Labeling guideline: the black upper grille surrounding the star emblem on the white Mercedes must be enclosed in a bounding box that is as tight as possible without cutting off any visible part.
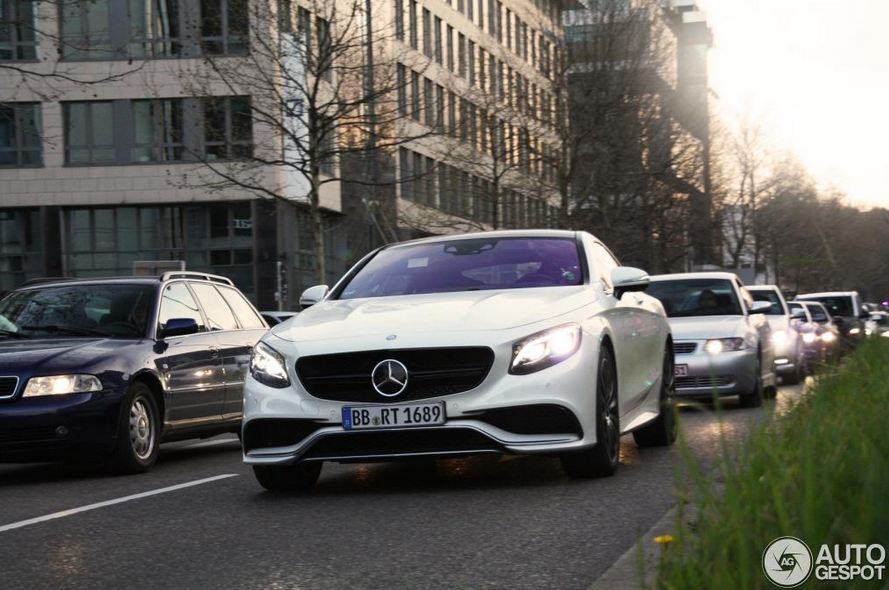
[296,346,494,403]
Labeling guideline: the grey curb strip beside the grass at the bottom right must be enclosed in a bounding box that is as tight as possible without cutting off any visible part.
[589,505,678,590]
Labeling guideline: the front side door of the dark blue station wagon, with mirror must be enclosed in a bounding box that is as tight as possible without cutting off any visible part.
[156,281,225,429]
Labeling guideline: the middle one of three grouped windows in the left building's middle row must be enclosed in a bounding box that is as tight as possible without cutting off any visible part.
[130,98,185,162]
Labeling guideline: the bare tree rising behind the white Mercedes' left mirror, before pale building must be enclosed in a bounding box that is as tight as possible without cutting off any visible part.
[183,0,430,282]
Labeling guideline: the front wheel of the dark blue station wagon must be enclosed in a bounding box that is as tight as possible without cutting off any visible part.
[111,381,160,473]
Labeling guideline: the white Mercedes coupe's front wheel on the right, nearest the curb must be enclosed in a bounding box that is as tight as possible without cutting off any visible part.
[561,346,620,479]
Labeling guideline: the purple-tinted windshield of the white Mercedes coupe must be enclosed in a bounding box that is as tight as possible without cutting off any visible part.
[339,238,583,299]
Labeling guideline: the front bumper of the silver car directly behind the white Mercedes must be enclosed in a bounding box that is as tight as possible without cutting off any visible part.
[675,341,757,397]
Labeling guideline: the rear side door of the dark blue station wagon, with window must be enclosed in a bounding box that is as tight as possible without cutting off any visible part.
[192,282,267,420]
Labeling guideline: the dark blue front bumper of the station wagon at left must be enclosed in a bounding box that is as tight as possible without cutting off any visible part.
[0,391,123,463]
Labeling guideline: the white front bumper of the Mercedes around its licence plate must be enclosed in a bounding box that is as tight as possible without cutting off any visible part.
[242,334,599,465]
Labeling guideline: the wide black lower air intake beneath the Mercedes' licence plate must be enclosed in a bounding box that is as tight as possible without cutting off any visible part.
[303,428,503,460]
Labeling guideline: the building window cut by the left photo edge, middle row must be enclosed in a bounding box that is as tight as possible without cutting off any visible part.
[0,102,43,168]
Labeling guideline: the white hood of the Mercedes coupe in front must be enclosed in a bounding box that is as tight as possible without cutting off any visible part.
[272,286,594,342]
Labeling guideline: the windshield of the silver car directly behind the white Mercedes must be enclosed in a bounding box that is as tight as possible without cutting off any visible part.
[645,279,741,318]
